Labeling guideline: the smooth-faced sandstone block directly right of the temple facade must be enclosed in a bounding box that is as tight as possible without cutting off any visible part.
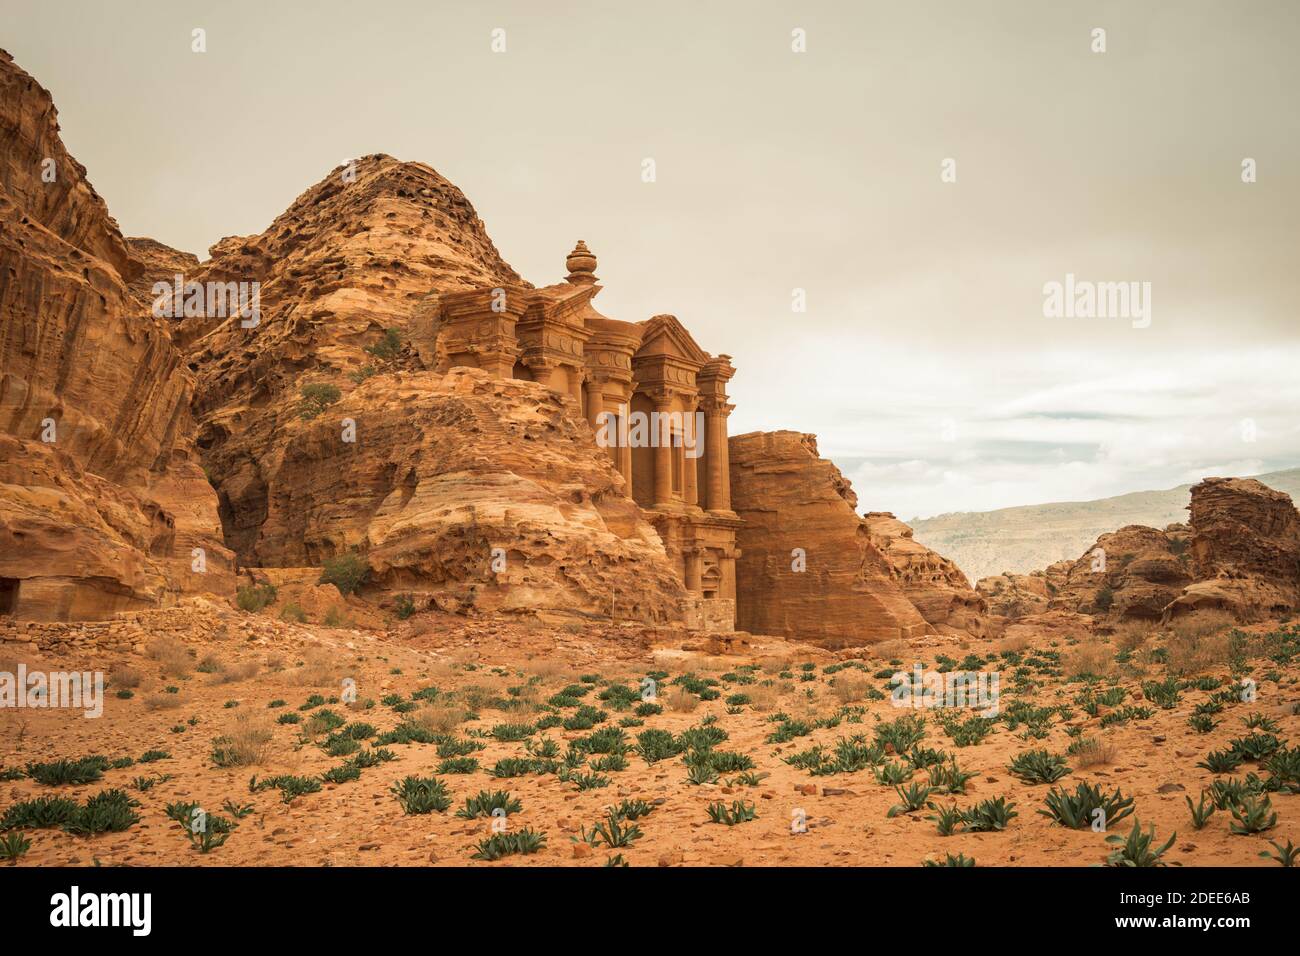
[729,432,978,648]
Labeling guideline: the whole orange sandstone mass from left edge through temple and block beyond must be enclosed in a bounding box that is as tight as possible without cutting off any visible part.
[0,48,984,646]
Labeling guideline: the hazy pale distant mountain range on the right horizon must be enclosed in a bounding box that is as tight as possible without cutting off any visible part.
[911,468,1300,584]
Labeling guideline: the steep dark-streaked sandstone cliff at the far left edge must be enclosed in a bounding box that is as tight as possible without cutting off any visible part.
[0,53,233,619]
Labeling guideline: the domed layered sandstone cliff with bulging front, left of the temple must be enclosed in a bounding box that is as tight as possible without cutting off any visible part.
[183,155,685,622]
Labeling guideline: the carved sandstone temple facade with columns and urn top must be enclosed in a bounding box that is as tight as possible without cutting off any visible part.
[434,241,741,631]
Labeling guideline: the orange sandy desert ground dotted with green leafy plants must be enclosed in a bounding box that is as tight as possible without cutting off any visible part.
[0,606,1300,866]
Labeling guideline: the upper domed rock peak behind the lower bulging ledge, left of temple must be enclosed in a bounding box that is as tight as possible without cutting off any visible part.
[182,156,521,564]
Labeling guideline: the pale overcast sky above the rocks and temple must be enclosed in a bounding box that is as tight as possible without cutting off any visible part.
[10,0,1300,519]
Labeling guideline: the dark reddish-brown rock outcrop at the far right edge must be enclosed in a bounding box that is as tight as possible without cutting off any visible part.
[1167,477,1300,620]
